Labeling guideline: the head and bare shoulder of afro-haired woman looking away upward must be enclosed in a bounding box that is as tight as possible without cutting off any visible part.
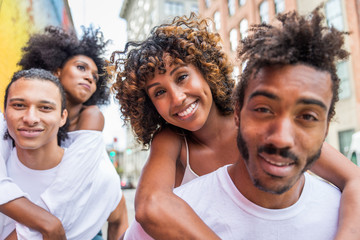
[18,26,109,131]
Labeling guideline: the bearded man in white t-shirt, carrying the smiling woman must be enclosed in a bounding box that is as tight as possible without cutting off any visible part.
[125,6,348,240]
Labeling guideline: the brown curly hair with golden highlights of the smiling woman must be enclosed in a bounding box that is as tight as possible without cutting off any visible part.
[111,13,234,146]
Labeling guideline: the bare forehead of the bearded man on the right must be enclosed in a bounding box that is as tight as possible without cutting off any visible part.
[245,64,333,105]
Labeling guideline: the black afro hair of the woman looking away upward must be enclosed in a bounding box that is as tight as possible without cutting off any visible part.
[18,26,110,105]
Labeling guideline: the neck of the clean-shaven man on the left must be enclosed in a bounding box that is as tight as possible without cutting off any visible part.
[16,144,64,170]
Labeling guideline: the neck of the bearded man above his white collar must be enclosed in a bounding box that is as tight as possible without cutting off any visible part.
[228,159,305,209]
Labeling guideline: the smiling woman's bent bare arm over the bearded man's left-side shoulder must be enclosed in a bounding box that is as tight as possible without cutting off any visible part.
[135,129,219,240]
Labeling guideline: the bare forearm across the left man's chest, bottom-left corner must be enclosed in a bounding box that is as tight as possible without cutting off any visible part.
[0,197,66,239]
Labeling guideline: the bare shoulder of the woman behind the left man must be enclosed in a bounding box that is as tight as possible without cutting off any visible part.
[77,105,105,131]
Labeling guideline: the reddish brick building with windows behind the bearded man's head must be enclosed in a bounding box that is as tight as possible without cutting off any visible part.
[199,0,360,161]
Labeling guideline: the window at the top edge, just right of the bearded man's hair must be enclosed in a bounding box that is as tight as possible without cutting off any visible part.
[325,0,344,31]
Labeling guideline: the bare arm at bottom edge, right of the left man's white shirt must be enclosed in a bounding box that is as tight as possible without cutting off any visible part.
[108,195,129,240]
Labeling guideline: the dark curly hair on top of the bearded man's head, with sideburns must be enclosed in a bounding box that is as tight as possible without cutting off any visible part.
[233,4,349,121]
